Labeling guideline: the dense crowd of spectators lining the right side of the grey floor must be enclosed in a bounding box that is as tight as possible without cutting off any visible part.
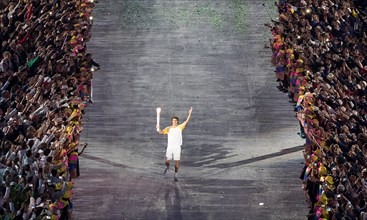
[269,0,367,220]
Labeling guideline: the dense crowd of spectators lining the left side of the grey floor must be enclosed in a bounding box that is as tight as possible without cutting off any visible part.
[0,0,98,220]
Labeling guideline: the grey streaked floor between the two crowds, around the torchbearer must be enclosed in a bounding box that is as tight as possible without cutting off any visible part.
[73,0,307,220]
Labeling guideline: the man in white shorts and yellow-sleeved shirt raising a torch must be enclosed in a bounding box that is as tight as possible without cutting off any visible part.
[157,107,192,181]
